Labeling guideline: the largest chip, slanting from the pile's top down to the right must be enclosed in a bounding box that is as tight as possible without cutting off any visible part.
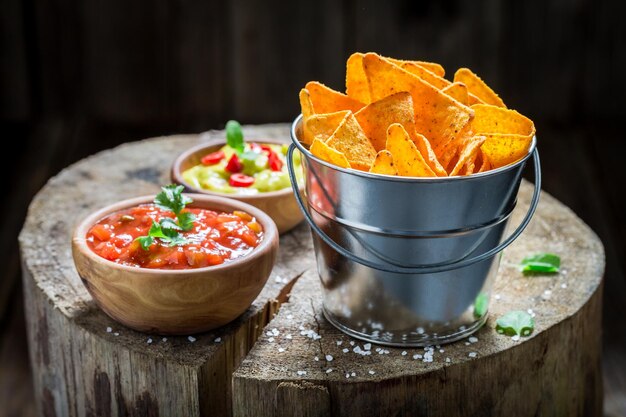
[363,54,473,154]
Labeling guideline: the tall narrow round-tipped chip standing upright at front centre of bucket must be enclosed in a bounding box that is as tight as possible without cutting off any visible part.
[387,123,436,177]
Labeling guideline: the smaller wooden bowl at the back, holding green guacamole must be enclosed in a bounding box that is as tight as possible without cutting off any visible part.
[171,139,304,234]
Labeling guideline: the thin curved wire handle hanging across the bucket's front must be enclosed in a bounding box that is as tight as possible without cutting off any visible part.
[287,143,541,274]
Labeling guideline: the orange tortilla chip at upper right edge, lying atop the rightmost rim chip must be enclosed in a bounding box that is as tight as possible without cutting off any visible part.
[472,104,535,136]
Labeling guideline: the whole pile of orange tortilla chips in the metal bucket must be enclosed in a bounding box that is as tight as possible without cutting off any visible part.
[300,53,535,177]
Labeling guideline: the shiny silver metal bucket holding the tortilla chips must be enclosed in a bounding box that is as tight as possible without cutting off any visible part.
[287,116,541,346]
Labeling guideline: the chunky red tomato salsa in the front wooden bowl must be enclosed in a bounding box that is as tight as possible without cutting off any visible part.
[87,204,263,269]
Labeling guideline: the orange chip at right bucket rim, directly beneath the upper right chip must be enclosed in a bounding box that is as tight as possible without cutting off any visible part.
[481,133,532,169]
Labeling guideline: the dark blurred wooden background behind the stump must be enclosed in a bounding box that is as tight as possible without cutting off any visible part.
[0,0,626,416]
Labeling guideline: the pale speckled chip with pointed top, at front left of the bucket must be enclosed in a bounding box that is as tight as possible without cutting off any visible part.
[326,112,376,171]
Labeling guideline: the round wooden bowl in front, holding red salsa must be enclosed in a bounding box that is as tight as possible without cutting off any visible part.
[72,194,278,334]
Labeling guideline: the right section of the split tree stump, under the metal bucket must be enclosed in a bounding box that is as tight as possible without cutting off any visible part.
[233,183,604,417]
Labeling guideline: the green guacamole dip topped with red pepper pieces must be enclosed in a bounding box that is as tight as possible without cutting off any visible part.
[183,143,303,195]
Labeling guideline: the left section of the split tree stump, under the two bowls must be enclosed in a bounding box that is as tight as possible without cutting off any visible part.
[20,125,313,417]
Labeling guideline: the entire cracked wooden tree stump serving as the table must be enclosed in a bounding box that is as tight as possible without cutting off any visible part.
[20,125,604,417]
